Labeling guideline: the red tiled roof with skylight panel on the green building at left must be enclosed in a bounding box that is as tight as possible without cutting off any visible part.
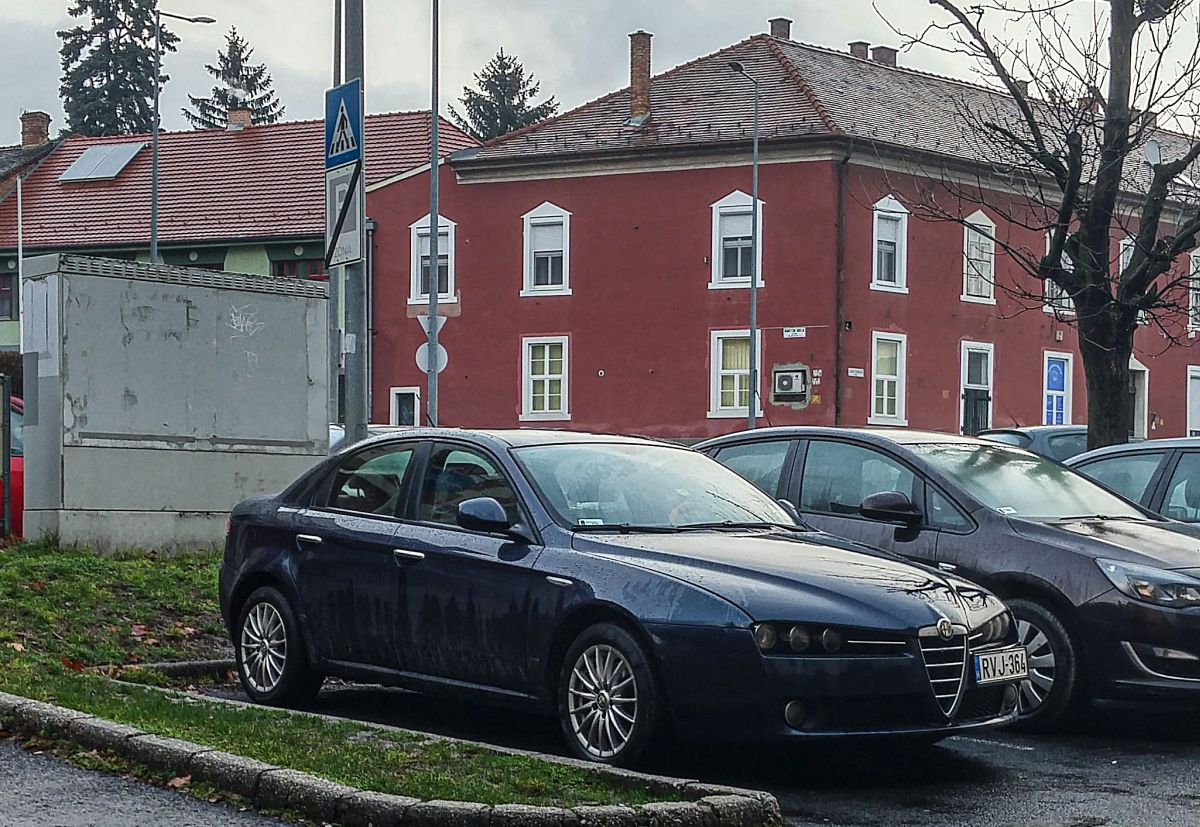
[0,112,476,250]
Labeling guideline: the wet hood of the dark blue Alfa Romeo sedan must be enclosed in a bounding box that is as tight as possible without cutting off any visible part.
[575,531,1001,631]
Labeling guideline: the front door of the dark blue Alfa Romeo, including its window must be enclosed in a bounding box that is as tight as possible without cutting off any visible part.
[396,442,560,694]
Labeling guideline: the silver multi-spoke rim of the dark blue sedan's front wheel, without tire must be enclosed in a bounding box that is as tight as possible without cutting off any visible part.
[568,643,637,759]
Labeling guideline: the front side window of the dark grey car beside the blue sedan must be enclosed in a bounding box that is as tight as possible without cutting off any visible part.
[800,441,916,515]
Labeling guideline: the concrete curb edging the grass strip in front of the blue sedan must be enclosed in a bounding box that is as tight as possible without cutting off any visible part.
[0,688,782,827]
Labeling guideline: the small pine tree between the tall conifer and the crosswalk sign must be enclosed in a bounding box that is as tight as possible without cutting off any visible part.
[184,28,283,130]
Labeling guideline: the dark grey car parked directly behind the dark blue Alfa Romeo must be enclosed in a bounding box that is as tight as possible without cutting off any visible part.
[697,427,1200,729]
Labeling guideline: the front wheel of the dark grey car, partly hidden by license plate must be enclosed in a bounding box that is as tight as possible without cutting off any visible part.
[1006,598,1084,732]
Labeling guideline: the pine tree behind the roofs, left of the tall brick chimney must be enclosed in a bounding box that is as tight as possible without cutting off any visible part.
[450,47,558,140]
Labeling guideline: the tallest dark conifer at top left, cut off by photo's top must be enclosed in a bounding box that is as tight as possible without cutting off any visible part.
[58,0,179,136]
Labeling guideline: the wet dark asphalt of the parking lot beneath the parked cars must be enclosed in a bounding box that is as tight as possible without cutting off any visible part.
[211,685,1200,827]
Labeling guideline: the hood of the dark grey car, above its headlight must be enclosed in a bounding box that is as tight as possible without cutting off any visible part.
[1009,519,1200,569]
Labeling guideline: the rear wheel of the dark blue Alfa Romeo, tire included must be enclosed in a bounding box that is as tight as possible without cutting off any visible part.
[234,586,324,706]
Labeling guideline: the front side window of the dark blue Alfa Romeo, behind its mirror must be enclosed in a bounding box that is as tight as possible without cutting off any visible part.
[416,445,521,526]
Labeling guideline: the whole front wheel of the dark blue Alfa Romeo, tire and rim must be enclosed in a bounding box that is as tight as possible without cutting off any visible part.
[558,623,662,767]
